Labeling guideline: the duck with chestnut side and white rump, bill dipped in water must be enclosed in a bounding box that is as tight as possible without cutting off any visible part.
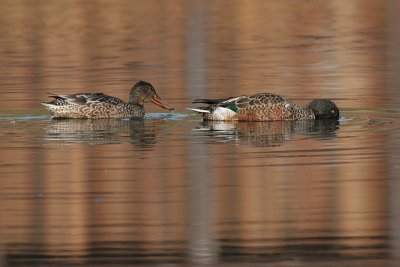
[189,93,339,121]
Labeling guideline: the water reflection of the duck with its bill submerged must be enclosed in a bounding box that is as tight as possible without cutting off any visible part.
[198,119,339,146]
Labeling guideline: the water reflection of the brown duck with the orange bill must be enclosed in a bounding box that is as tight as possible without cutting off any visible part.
[46,119,162,147]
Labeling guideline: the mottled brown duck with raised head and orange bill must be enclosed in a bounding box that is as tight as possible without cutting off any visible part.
[41,81,174,119]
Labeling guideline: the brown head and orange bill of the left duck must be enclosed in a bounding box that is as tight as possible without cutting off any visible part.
[128,81,174,110]
